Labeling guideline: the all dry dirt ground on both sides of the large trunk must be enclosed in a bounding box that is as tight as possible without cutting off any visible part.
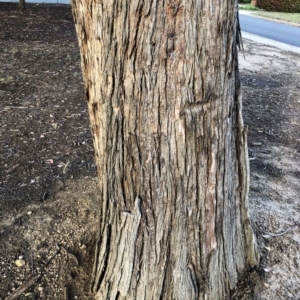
[0,3,300,300]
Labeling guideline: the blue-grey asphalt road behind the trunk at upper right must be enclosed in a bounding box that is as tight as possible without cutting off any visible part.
[239,14,300,47]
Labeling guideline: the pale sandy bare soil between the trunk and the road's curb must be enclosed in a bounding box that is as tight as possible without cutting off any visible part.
[240,41,300,300]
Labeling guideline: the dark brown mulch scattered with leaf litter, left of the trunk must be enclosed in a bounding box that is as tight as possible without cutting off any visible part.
[0,3,96,218]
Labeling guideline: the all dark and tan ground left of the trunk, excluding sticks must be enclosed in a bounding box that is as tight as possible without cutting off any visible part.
[0,3,97,300]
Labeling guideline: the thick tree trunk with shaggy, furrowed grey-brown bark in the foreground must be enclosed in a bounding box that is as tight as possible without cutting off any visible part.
[72,0,258,300]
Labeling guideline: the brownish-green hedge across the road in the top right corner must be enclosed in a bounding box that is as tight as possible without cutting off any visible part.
[256,0,300,13]
